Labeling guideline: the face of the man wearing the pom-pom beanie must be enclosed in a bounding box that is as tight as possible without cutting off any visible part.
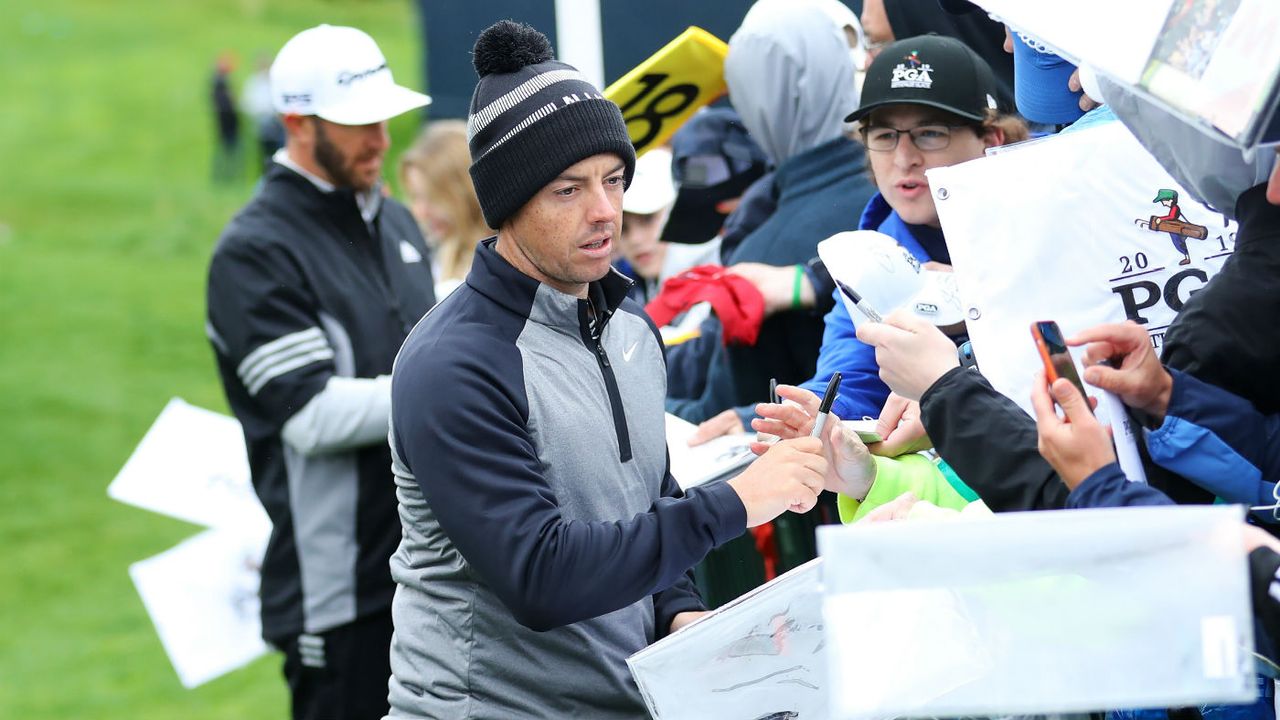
[498,152,626,297]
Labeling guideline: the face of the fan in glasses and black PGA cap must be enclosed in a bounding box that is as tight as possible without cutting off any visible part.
[867,105,996,227]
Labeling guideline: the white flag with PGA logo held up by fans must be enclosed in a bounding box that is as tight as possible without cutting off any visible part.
[927,122,1235,448]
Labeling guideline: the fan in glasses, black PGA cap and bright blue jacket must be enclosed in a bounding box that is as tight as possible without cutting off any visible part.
[768,35,1027,455]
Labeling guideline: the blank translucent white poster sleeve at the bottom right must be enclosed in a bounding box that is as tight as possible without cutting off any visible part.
[819,505,1256,720]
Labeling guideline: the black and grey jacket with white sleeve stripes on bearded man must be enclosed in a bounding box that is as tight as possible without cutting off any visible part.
[206,164,435,641]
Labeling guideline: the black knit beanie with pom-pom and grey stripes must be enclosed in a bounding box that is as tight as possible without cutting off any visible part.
[467,20,636,228]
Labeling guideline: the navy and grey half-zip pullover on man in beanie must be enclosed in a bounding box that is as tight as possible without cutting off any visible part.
[390,240,746,719]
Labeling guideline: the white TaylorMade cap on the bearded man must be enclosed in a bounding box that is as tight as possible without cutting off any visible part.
[270,24,431,126]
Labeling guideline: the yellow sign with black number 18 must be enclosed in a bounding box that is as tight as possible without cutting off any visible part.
[604,27,728,155]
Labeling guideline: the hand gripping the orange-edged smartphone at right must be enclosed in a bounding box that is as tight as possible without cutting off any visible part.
[1032,372,1116,489]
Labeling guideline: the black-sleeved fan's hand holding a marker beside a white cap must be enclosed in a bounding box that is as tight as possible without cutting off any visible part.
[858,310,960,401]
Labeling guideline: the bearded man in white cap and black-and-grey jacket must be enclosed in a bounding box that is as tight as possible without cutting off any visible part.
[205,26,435,719]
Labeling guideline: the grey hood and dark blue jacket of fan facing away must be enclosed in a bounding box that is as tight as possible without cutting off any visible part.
[724,0,874,405]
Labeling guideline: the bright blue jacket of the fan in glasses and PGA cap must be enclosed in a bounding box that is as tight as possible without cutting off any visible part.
[801,193,932,419]
